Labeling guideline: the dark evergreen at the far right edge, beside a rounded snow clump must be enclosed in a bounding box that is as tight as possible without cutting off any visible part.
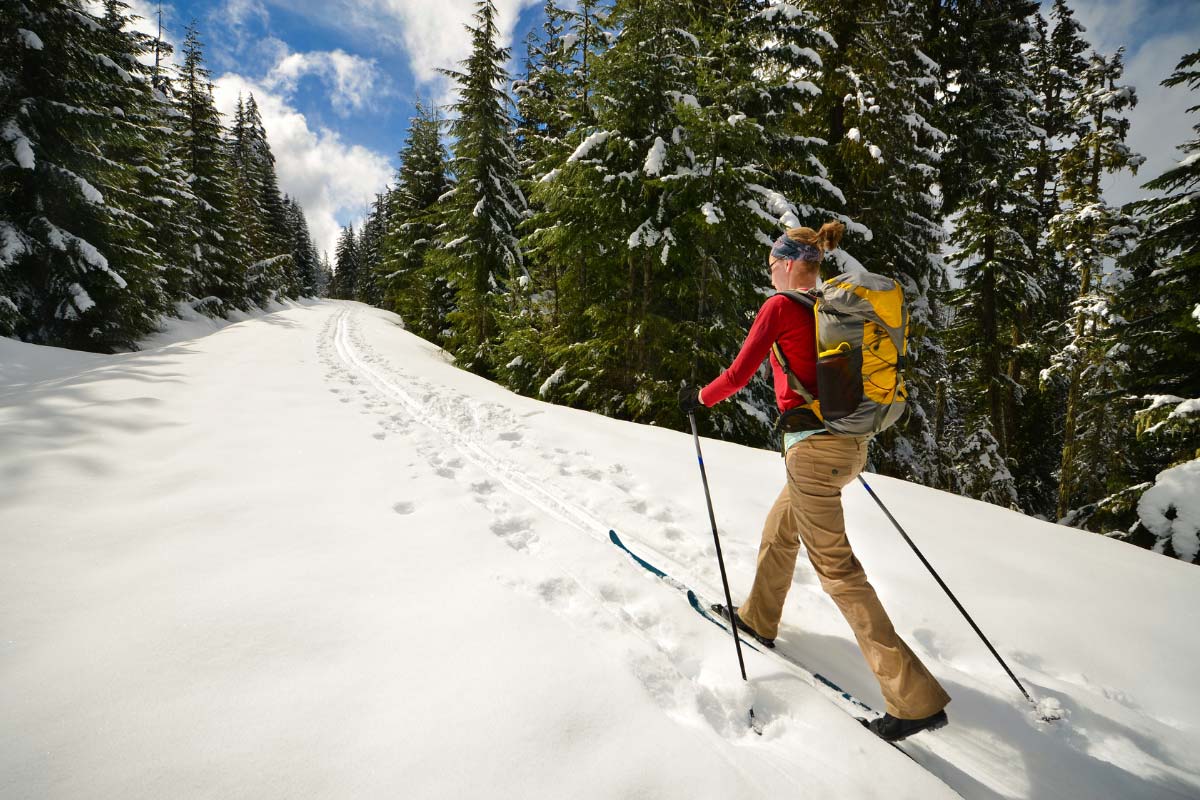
[1076,50,1200,561]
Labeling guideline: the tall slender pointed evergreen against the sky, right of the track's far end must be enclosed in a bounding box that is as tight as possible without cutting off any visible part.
[437,0,526,374]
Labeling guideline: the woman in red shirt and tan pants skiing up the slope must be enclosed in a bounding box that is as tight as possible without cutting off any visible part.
[679,222,950,741]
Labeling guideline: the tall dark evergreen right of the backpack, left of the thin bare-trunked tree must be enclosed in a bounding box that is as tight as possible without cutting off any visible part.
[935,0,1043,506]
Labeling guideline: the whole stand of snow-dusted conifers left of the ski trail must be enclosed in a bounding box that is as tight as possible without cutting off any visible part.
[0,0,325,353]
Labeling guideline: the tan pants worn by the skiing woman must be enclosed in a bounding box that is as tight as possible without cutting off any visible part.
[738,434,950,720]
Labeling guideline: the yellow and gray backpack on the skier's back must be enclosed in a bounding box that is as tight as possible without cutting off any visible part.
[773,272,908,437]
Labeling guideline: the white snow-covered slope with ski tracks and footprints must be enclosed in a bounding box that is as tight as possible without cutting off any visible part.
[0,302,1200,800]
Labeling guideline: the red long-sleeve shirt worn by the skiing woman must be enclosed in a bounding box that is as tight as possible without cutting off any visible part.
[701,294,817,411]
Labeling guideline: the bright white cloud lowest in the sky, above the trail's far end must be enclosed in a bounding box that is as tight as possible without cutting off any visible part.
[214,73,392,258]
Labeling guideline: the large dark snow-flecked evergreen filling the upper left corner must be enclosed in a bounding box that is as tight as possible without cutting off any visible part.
[0,0,167,351]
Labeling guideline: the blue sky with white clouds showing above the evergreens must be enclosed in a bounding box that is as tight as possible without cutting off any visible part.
[126,0,1200,260]
